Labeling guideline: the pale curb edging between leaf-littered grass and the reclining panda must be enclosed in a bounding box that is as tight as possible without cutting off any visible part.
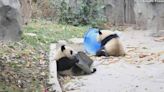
[49,44,62,92]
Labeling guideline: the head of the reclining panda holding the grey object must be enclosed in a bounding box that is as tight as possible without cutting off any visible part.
[55,45,76,60]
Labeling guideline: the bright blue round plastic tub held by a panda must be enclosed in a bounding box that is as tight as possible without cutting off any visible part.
[84,28,101,55]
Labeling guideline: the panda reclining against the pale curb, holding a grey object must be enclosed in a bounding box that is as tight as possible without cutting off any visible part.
[55,45,96,75]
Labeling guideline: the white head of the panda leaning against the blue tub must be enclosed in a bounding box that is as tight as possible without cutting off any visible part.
[97,30,113,42]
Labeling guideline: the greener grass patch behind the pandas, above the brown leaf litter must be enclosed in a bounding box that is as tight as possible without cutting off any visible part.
[22,20,89,49]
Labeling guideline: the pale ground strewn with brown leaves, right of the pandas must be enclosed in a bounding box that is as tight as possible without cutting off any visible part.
[56,31,164,92]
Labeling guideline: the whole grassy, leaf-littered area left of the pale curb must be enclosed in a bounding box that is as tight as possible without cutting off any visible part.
[0,20,88,92]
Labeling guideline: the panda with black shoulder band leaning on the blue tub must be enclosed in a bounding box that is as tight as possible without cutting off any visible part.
[96,30,125,56]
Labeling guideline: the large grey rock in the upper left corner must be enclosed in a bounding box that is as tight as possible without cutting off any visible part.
[0,0,22,41]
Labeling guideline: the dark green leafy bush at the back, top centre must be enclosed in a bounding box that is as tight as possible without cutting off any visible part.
[56,0,107,27]
